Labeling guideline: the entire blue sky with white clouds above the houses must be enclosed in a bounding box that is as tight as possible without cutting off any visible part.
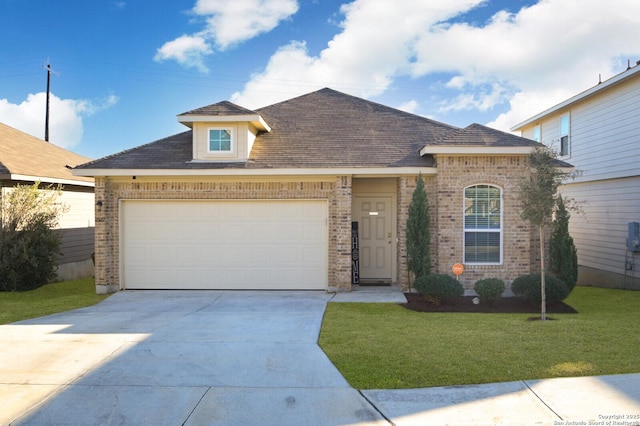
[0,0,640,158]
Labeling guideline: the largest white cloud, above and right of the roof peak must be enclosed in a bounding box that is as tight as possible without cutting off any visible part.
[232,0,640,130]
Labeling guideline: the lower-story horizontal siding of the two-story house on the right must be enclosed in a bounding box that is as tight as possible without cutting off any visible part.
[562,177,640,277]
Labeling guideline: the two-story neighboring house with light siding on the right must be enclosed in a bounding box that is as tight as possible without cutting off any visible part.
[513,65,640,289]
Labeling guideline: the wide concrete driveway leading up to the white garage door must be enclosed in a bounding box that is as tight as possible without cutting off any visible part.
[0,291,388,426]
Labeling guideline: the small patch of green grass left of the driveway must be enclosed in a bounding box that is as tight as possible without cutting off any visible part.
[0,278,108,324]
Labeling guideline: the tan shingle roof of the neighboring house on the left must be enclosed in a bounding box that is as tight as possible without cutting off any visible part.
[0,123,93,182]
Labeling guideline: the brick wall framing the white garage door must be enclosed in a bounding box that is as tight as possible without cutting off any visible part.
[95,176,351,293]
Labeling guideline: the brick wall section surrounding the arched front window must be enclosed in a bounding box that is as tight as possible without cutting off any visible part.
[436,155,531,289]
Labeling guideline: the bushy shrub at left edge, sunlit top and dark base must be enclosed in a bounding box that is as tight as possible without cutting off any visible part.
[0,182,65,291]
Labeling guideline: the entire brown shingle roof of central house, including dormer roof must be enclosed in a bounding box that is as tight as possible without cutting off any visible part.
[78,88,535,169]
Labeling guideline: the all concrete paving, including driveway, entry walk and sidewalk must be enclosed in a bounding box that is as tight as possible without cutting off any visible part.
[0,287,640,425]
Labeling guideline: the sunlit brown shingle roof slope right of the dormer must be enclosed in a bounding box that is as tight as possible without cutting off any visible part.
[250,89,456,168]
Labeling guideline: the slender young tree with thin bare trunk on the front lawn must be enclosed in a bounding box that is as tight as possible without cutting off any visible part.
[519,145,566,321]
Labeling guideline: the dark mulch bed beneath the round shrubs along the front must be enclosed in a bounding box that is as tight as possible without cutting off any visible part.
[400,293,578,314]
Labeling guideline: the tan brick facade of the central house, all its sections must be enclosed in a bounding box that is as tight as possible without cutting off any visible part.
[95,155,539,293]
